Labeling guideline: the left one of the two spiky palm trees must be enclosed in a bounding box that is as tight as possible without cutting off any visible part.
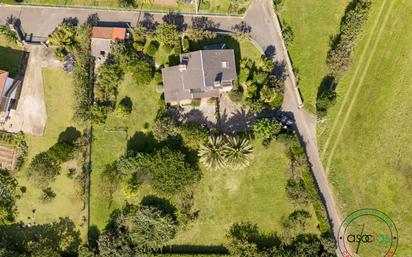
[199,136,226,170]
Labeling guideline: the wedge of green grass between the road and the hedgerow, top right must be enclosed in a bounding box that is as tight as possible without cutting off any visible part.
[280,0,349,113]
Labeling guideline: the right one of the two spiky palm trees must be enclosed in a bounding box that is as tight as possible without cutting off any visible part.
[224,136,253,169]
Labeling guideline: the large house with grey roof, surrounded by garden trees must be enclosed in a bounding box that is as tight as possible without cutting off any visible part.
[162,49,237,105]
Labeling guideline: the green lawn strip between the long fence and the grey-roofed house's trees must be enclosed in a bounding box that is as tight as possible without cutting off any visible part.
[90,76,160,229]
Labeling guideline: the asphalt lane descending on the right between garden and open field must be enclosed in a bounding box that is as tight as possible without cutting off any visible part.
[244,0,341,238]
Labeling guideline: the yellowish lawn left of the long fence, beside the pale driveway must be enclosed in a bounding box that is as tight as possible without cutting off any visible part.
[16,69,86,238]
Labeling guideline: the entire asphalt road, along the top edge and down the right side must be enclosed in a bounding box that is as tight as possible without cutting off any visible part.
[0,0,341,240]
